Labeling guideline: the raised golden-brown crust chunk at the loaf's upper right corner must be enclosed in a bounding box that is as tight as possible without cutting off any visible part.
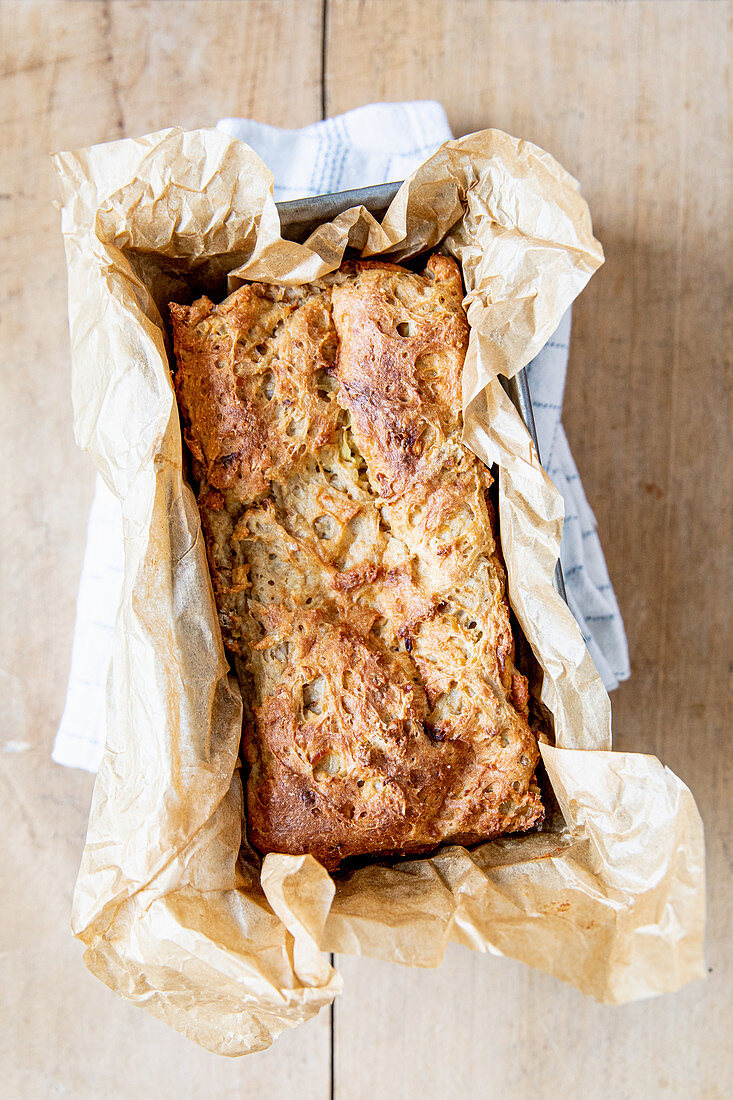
[333,255,468,497]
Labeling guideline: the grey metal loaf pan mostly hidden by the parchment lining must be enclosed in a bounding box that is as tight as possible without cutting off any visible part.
[277,182,567,602]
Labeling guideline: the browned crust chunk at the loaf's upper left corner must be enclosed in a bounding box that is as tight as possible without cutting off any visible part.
[171,283,336,501]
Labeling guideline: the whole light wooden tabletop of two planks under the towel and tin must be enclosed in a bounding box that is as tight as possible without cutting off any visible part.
[0,0,733,1100]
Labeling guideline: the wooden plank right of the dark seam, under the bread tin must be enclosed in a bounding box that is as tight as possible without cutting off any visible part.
[326,0,733,1100]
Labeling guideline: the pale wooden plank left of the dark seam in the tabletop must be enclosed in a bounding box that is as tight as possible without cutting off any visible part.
[0,0,330,1100]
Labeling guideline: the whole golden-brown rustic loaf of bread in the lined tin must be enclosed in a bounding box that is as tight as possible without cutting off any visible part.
[171,254,543,869]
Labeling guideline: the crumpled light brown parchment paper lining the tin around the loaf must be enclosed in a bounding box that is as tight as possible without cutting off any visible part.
[55,130,703,1054]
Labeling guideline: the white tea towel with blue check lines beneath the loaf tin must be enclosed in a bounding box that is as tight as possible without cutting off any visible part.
[53,101,628,771]
